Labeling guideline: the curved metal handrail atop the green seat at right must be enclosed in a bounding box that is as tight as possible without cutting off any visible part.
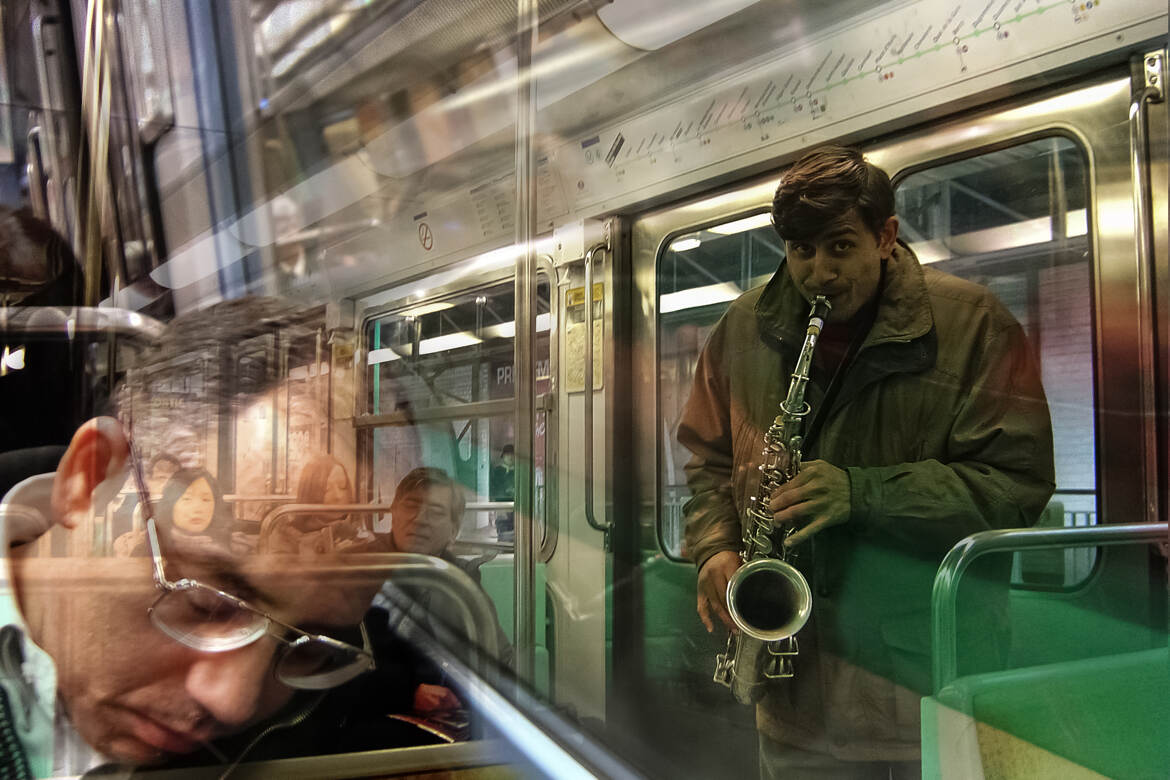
[930,523,1166,693]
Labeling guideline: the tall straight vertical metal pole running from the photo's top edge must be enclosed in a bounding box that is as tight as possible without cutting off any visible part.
[512,0,539,682]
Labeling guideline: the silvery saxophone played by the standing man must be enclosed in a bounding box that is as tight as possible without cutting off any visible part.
[714,295,832,704]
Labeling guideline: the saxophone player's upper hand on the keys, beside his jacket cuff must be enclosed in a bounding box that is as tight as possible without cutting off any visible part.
[768,461,852,547]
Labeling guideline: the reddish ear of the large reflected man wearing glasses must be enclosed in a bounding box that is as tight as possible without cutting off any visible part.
[53,417,130,529]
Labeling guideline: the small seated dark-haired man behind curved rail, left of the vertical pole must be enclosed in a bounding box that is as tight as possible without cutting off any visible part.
[374,467,511,716]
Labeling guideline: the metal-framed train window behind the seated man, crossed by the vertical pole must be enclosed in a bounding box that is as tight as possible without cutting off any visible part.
[355,263,564,692]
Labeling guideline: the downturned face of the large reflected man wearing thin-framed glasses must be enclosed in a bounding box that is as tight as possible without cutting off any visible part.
[17,411,374,764]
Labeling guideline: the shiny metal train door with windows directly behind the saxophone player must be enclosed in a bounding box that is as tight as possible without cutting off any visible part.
[615,62,1165,774]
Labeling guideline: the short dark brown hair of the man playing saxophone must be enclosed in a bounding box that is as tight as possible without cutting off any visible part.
[772,146,894,241]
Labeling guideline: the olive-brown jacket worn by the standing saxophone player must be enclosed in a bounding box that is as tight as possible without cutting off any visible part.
[679,243,1054,760]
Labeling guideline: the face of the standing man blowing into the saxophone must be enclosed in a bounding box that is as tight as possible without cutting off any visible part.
[784,210,897,323]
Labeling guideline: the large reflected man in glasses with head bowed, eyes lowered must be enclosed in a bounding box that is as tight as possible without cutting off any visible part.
[0,301,413,776]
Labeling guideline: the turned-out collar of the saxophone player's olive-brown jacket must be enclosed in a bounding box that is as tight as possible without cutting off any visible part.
[756,240,935,348]
